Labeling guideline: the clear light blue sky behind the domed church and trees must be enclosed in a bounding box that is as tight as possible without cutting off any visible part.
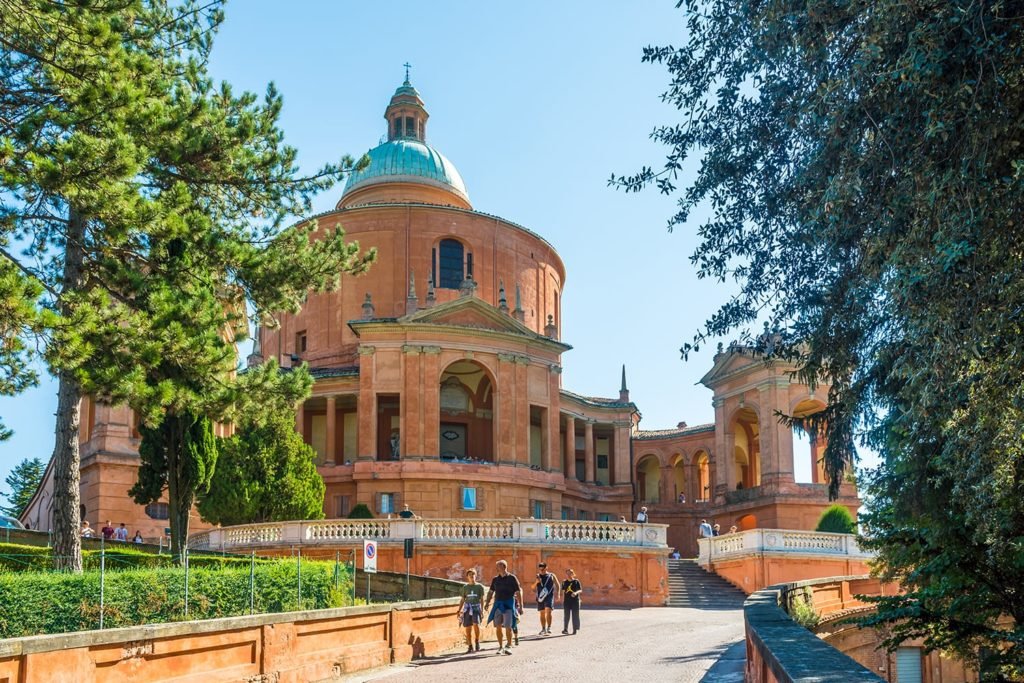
[0,0,835,490]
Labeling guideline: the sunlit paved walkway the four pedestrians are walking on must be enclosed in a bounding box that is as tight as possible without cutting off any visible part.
[344,605,743,683]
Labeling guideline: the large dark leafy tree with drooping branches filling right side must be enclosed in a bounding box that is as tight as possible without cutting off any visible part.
[611,0,1024,677]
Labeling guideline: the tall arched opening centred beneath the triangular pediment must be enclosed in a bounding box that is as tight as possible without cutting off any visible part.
[438,360,495,463]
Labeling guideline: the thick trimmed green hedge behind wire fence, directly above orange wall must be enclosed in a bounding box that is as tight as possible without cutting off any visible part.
[0,559,352,638]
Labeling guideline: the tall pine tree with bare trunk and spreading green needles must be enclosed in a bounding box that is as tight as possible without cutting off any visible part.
[0,0,373,570]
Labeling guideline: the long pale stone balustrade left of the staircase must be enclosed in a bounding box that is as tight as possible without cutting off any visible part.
[188,518,668,551]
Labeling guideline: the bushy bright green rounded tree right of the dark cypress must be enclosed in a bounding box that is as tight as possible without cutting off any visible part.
[199,410,325,526]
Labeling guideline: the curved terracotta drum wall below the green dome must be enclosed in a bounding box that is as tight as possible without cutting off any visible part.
[253,205,565,367]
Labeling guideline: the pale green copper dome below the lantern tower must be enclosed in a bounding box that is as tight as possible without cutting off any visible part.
[341,137,469,203]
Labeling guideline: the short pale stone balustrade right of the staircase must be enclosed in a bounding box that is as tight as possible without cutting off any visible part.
[697,528,874,566]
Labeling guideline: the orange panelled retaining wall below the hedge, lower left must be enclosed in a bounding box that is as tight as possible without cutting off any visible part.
[0,593,463,683]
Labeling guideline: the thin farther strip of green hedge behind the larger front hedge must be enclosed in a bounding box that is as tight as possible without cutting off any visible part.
[0,543,263,571]
